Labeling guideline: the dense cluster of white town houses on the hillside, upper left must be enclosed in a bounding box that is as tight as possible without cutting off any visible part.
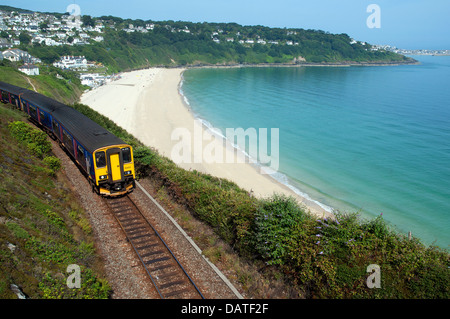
[0,11,112,87]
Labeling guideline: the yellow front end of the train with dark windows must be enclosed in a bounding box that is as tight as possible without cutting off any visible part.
[93,144,135,196]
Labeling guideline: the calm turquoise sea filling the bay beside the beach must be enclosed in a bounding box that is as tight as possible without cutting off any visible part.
[180,56,450,249]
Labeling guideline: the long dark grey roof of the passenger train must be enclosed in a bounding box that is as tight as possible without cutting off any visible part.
[0,81,125,153]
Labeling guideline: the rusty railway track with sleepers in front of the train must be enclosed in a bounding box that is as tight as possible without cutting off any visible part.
[104,196,204,299]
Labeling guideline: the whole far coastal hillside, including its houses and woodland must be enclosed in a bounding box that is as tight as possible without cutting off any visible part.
[0,7,414,73]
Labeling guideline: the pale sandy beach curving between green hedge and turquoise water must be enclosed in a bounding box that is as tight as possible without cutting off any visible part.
[80,68,332,217]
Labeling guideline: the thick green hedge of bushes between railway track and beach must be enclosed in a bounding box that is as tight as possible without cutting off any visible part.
[74,104,450,299]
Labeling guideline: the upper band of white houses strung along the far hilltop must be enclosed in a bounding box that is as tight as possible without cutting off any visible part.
[0,7,308,50]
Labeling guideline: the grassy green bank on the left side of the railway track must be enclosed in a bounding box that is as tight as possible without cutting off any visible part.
[0,106,111,299]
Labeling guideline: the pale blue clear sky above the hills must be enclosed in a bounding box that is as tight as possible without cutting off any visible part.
[0,0,450,49]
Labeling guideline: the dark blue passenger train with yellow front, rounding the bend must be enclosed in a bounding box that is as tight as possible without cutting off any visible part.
[0,81,136,197]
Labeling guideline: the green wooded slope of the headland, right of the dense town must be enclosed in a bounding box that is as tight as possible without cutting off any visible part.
[20,16,412,73]
